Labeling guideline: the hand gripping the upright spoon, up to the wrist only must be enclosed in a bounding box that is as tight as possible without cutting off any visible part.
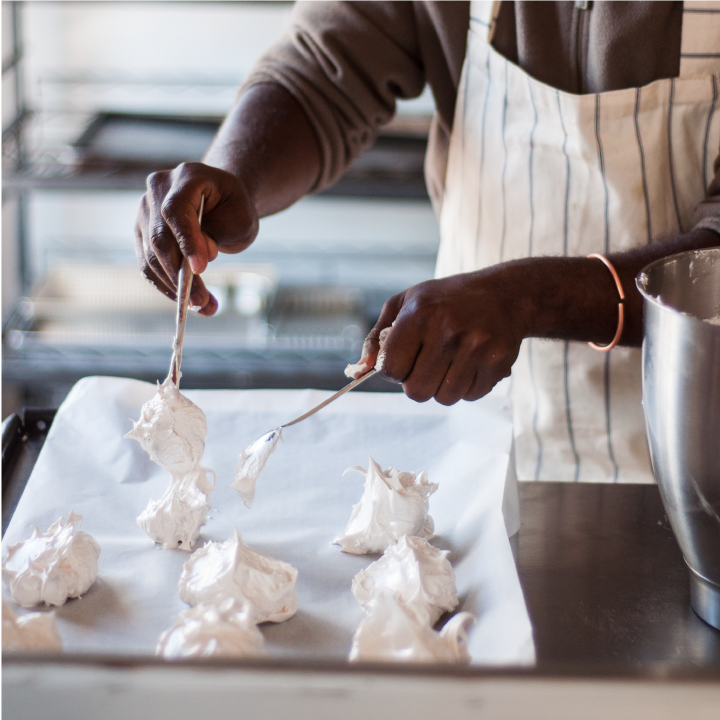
[135,163,258,315]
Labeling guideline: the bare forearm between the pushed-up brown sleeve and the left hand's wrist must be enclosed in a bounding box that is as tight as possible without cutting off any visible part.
[204,83,320,217]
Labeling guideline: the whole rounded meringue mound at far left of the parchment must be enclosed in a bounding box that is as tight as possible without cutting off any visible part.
[2,511,100,608]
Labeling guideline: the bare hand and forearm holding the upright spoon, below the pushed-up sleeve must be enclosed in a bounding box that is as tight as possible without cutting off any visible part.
[135,83,320,315]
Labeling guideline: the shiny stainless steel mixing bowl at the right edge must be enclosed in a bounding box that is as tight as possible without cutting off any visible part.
[636,248,720,629]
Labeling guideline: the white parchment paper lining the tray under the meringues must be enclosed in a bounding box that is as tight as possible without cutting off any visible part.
[2,377,534,664]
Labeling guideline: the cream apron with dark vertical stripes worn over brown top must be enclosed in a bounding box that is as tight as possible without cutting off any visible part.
[436,0,720,482]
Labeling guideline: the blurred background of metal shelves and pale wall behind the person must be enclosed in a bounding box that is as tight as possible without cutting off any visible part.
[2,0,439,418]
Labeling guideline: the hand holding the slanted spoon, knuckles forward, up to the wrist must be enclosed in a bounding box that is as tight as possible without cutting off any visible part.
[363,269,528,405]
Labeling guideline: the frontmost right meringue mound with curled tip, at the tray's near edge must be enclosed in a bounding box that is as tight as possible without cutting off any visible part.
[349,591,475,663]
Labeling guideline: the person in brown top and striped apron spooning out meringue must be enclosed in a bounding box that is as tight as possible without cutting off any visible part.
[136,0,720,482]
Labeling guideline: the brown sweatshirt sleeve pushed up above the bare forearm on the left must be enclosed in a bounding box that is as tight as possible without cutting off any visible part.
[240,0,425,190]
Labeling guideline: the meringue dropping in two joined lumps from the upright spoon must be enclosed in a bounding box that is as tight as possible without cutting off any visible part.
[125,378,215,552]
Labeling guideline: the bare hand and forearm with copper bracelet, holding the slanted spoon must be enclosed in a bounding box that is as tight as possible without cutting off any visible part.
[361,229,718,405]
